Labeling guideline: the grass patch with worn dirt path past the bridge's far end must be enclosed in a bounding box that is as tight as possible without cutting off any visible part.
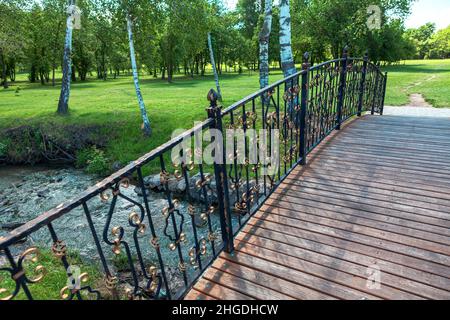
[383,59,450,107]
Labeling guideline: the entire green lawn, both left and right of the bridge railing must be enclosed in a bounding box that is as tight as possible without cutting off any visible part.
[0,60,450,171]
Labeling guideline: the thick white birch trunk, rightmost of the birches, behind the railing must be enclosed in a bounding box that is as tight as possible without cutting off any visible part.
[280,0,297,77]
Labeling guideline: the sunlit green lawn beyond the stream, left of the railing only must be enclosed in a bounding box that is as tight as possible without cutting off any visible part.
[0,71,282,171]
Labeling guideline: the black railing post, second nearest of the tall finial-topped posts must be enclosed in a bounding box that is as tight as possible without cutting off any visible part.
[297,52,310,165]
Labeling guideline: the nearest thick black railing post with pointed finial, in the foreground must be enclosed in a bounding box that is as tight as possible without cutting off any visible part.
[206,89,234,253]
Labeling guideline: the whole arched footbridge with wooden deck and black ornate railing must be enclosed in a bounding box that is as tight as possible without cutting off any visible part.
[0,52,450,300]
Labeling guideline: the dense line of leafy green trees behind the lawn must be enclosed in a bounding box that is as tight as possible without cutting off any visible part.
[0,0,450,87]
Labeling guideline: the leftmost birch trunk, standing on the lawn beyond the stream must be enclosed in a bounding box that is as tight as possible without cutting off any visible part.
[58,0,75,114]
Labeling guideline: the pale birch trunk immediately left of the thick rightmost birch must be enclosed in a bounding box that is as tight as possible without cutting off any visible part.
[259,0,272,89]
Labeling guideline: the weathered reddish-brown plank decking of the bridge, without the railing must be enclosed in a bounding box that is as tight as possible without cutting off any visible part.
[186,116,450,299]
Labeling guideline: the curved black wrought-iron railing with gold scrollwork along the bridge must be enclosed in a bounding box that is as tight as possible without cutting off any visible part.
[0,47,387,300]
